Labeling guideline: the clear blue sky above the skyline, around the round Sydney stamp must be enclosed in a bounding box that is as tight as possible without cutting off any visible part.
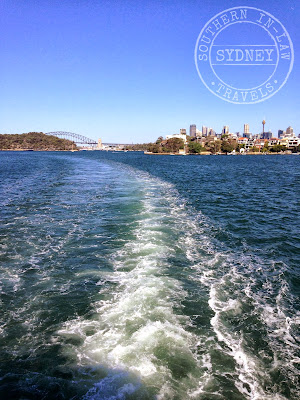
[0,0,300,143]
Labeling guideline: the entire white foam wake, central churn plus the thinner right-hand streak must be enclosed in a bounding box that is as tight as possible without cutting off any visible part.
[55,161,296,400]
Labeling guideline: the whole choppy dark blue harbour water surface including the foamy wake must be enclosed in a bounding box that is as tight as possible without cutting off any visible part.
[0,152,300,400]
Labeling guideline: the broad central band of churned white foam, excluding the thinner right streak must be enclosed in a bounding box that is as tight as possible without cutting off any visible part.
[59,176,203,399]
